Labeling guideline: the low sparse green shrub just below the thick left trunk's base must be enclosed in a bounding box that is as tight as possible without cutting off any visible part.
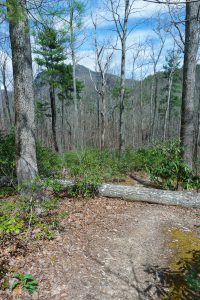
[0,192,68,243]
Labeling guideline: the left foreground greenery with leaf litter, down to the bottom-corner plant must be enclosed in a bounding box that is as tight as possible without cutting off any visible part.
[0,193,68,294]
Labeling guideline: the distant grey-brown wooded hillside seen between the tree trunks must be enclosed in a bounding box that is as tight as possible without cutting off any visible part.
[0,65,200,150]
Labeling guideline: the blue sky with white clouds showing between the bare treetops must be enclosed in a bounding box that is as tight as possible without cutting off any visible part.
[1,0,183,82]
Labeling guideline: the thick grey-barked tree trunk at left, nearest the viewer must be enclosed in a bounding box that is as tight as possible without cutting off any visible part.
[7,0,38,183]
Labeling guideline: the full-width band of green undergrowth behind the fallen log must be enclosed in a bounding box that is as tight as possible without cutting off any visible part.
[0,132,200,196]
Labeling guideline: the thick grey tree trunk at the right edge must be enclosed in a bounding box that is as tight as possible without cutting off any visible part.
[180,1,199,168]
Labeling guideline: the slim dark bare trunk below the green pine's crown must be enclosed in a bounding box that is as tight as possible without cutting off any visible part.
[49,86,59,152]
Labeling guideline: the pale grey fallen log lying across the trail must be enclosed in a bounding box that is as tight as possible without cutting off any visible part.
[59,180,200,208]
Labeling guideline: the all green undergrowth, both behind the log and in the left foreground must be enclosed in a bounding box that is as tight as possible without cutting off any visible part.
[0,132,200,293]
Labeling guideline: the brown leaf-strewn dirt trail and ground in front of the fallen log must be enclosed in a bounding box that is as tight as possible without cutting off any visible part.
[0,198,200,300]
